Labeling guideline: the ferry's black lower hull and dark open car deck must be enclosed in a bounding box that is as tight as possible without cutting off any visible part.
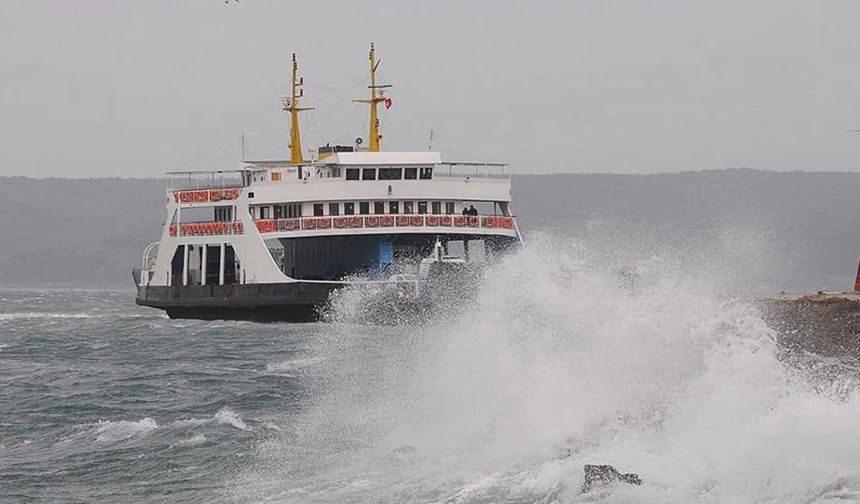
[136,234,519,321]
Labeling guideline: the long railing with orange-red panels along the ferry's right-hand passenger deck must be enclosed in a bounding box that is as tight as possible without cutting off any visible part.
[254,214,516,233]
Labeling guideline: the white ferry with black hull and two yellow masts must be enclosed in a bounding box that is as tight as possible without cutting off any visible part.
[135,45,522,321]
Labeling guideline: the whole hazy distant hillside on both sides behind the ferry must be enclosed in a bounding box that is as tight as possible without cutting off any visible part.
[0,170,860,290]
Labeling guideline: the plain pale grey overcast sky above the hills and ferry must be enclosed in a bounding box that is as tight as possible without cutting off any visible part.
[0,0,860,177]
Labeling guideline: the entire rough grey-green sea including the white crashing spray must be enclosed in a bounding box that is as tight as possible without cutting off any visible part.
[0,242,860,504]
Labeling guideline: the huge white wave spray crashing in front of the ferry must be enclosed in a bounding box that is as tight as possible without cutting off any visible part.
[232,237,860,503]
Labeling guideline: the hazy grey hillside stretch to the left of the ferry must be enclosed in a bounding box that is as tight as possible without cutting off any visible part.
[0,177,166,287]
